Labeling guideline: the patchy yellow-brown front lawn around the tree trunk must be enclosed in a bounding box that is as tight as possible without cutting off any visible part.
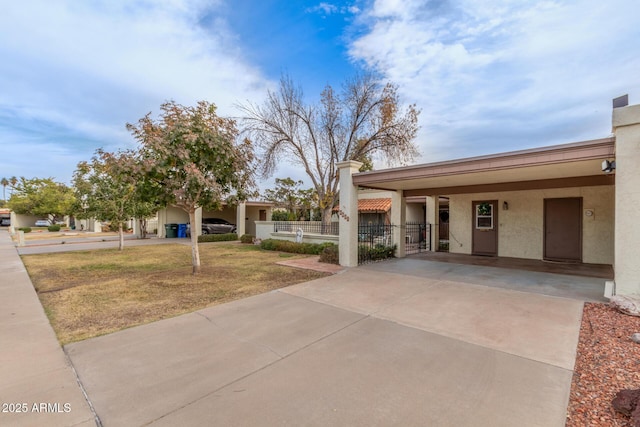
[22,243,326,345]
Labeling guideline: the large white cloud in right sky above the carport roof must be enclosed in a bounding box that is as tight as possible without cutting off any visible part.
[350,0,640,161]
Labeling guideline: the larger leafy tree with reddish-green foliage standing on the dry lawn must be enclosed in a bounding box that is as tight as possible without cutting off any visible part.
[127,101,253,274]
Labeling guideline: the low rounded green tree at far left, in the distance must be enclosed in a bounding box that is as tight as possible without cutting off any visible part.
[8,177,75,223]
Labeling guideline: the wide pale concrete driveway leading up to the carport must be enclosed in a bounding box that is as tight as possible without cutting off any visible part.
[66,263,583,427]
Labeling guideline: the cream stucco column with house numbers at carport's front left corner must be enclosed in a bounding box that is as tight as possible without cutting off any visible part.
[337,160,362,267]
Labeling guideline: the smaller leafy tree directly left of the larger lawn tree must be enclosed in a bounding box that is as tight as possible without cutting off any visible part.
[73,150,158,250]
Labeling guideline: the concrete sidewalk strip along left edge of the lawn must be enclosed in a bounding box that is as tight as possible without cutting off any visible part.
[0,230,96,426]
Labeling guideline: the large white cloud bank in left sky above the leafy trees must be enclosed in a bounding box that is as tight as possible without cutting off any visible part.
[0,0,269,162]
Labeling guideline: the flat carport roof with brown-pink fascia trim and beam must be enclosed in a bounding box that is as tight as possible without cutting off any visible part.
[353,137,615,197]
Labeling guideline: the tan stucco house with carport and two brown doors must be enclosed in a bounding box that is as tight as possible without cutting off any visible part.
[340,97,640,293]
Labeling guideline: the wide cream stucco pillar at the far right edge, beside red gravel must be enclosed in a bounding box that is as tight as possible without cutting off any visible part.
[603,105,640,295]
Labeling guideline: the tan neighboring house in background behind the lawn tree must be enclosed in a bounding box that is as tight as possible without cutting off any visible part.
[157,201,273,238]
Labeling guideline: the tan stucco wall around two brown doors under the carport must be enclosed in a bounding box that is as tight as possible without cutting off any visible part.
[449,186,614,264]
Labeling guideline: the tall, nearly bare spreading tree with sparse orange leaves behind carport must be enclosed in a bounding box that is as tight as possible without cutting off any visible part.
[240,74,419,231]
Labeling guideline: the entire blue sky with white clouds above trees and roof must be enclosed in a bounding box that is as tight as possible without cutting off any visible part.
[0,0,640,194]
